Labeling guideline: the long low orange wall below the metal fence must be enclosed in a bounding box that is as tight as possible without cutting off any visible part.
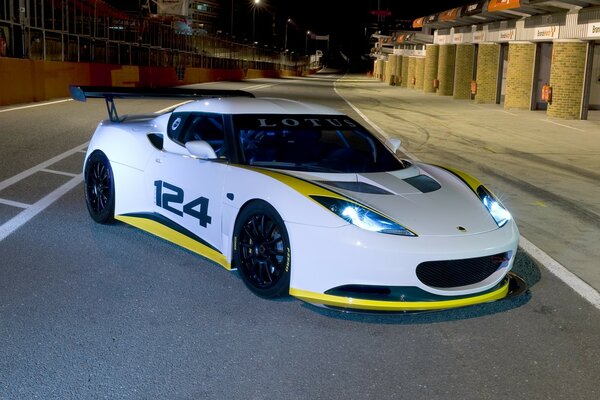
[0,58,300,106]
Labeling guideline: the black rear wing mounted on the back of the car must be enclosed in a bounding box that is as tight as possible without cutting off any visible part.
[69,85,254,122]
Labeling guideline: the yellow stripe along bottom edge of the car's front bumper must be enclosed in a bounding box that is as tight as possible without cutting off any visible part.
[290,279,509,311]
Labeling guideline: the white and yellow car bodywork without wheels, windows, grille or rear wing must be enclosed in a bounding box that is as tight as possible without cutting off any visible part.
[76,88,519,311]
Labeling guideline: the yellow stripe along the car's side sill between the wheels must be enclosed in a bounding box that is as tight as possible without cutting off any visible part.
[115,215,231,270]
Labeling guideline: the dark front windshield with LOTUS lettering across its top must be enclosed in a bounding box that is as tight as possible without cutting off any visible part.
[233,114,404,173]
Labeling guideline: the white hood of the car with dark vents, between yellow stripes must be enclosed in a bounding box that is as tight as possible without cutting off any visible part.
[286,165,498,236]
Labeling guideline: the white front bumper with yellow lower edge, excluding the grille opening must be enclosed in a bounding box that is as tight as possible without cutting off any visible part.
[287,222,519,311]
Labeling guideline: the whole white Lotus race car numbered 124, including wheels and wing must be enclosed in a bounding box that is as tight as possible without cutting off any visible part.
[71,87,519,311]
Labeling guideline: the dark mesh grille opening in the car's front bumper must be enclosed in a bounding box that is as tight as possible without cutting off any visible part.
[417,252,510,288]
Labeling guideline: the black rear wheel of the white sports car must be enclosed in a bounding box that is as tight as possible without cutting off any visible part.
[84,151,115,224]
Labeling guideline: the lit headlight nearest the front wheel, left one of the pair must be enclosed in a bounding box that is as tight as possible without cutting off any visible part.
[311,196,417,236]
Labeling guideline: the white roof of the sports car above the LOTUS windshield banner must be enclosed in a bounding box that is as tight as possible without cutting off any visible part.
[174,97,344,115]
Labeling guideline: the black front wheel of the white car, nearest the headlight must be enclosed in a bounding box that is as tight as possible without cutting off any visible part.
[233,201,291,298]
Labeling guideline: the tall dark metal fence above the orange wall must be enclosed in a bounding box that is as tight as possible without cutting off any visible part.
[0,0,308,73]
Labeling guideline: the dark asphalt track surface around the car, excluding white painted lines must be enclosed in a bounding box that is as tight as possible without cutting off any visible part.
[0,74,600,400]
